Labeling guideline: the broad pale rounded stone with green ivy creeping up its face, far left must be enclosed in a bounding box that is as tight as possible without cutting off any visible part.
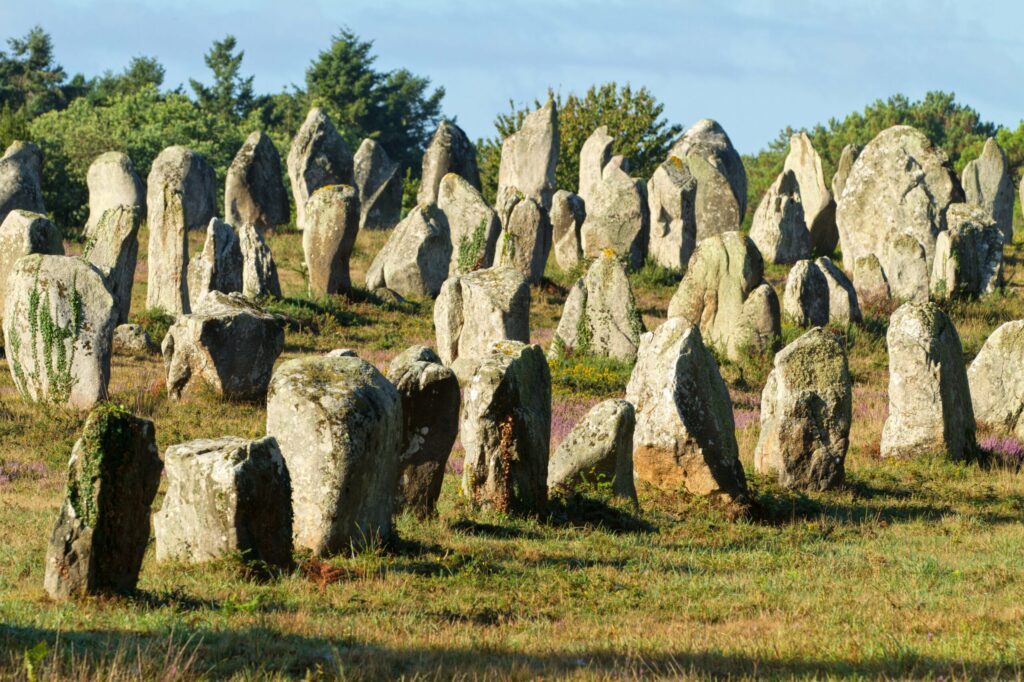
[3,254,117,410]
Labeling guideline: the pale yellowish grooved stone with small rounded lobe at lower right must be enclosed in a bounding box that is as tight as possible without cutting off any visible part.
[667,232,780,360]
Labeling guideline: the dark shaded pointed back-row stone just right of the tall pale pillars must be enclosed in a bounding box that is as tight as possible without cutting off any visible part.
[224,130,291,233]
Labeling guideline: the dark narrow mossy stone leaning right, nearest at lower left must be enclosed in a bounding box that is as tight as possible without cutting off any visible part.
[43,404,163,599]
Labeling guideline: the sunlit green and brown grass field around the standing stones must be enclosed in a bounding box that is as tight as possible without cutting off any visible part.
[0,225,1024,680]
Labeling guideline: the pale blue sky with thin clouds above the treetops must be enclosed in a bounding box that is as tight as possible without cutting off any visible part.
[0,0,1024,153]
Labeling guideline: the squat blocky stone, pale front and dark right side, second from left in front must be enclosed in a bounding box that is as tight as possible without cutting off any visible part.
[153,436,292,568]
